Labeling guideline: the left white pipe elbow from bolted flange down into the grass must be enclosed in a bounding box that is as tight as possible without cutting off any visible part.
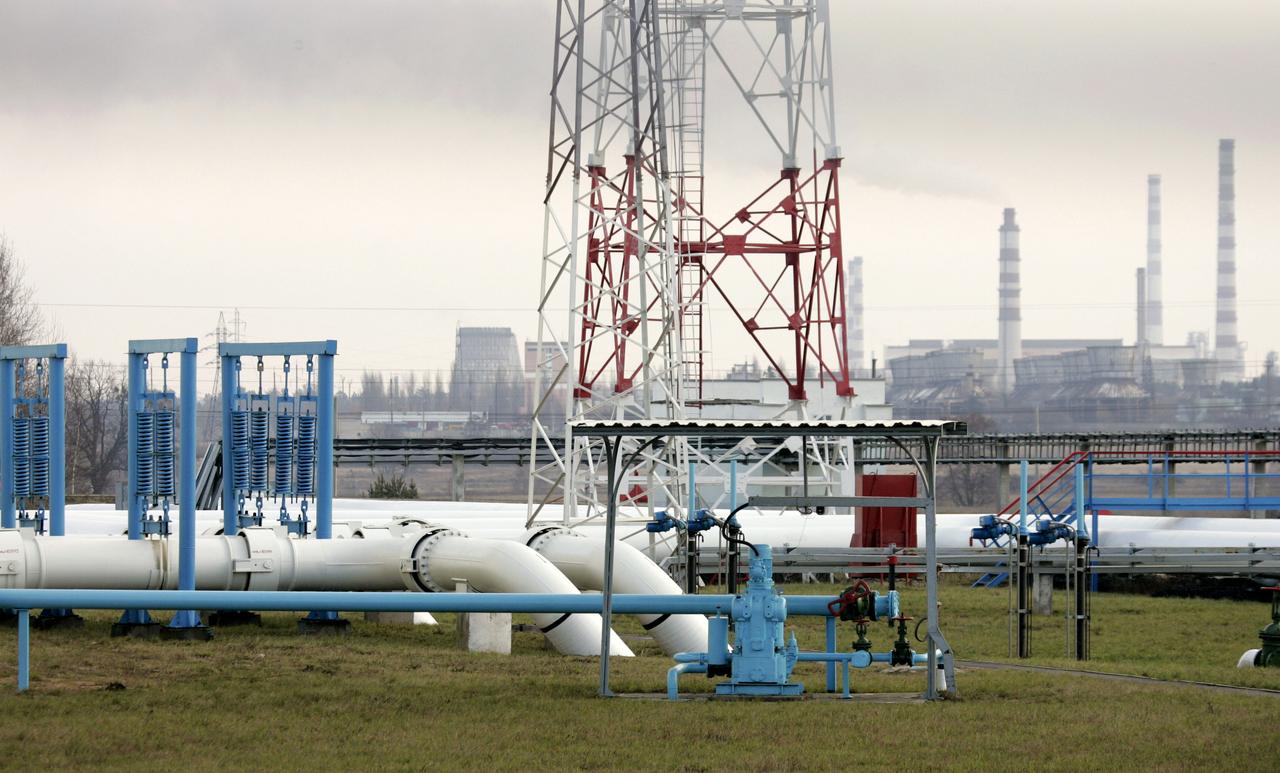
[413,529,634,658]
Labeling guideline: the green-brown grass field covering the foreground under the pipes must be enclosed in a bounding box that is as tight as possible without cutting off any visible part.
[0,582,1280,770]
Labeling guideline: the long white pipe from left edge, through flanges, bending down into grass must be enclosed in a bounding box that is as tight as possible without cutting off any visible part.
[0,523,634,657]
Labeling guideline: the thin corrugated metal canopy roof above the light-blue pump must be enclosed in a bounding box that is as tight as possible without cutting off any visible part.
[570,418,968,438]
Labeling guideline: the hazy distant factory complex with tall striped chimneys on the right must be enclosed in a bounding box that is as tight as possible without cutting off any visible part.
[880,139,1275,431]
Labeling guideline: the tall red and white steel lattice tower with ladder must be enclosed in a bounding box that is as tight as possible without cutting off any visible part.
[530,0,852,521]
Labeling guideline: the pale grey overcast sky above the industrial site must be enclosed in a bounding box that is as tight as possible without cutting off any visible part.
[0,0,1280,381]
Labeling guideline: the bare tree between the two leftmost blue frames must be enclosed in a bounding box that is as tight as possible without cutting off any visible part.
[67,361,129,494]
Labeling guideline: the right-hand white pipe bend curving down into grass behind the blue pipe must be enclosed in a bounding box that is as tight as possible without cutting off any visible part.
[525,526,707,655]
